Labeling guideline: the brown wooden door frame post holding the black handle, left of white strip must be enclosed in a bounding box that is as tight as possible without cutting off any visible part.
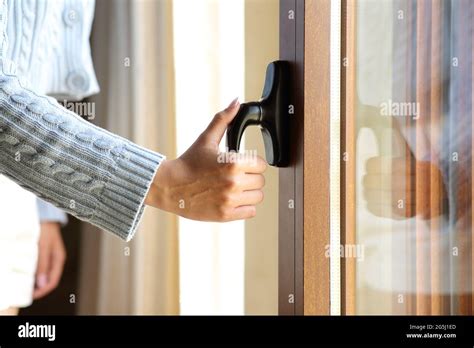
[278,0,331,315]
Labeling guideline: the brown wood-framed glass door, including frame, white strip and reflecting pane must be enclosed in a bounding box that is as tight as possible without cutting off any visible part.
[279,0,474,315]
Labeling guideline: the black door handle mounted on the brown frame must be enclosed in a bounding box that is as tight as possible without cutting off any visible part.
[226,61,290,167]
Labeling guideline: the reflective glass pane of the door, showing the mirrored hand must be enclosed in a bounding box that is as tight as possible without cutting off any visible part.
[343,0,474,315]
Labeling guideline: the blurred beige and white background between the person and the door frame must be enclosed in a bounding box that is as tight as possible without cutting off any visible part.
[21,0,279,315]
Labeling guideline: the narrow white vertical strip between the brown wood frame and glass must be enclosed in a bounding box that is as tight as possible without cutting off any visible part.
[329,0,342,315]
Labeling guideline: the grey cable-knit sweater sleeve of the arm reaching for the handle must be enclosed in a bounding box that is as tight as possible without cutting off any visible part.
[0,65,164,241]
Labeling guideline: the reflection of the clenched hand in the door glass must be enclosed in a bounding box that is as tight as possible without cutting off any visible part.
[363,157,446,219]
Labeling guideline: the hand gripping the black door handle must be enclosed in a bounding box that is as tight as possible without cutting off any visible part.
[146,101,267,222]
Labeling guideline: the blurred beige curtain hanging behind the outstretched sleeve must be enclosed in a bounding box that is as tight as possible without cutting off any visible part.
[77,0,179,314]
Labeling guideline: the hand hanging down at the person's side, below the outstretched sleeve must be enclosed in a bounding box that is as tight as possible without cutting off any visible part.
[33,222,66,300]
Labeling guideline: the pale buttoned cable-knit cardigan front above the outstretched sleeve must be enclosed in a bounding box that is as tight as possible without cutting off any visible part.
[5,0,99,100]
